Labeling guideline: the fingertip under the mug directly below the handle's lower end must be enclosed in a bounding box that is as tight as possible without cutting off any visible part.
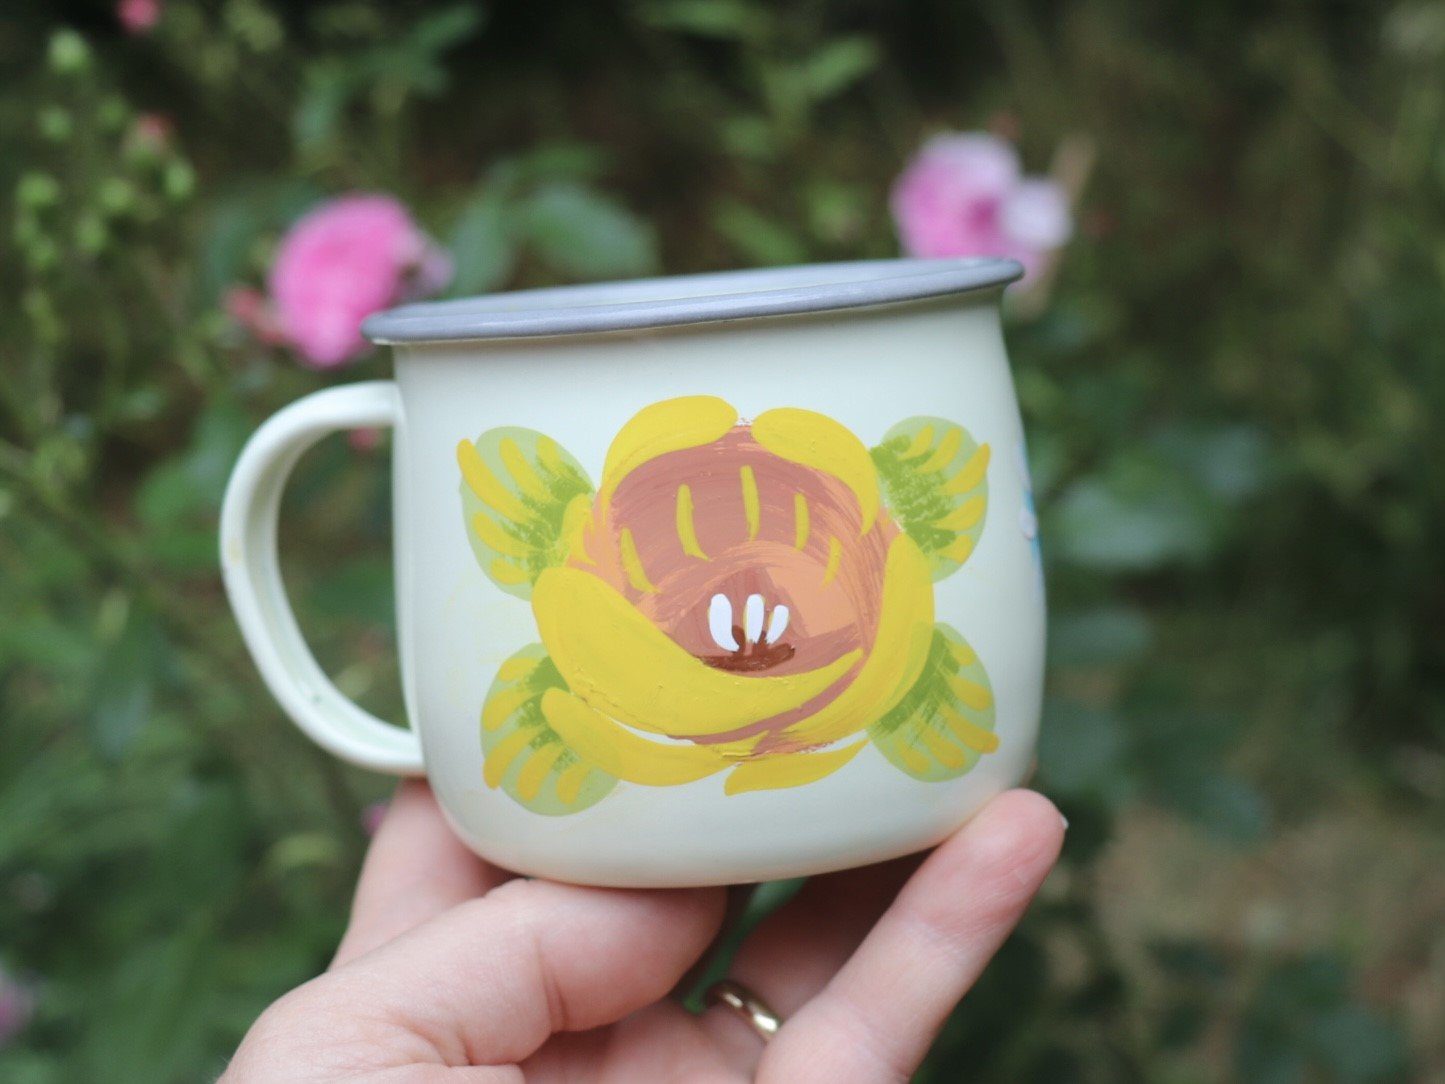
[331,780,506,967]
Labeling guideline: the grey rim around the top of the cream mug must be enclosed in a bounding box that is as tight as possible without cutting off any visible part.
[361,257,1023,344]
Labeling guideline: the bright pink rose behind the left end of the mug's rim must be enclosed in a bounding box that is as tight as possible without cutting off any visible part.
[267,195,452,369]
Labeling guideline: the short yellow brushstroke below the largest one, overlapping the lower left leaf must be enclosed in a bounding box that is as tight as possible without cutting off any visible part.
[542,689,730,786]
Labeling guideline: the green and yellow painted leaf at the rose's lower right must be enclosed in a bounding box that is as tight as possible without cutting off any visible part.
[868,623,998,782]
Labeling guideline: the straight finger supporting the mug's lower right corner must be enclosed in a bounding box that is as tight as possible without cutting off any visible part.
[759,791,1064,1084]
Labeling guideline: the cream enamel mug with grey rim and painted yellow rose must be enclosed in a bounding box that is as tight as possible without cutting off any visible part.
[221,260,1043,886]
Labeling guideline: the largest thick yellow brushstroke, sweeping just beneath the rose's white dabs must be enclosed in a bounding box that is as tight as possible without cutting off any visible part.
[532,568,861,737]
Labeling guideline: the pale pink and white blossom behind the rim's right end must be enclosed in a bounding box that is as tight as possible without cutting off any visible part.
[892,132,1074,276]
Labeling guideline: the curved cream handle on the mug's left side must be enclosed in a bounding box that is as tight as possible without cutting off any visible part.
[221,380,425,775]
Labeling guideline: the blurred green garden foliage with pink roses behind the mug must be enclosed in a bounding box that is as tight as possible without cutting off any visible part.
[0,0,1445,1084]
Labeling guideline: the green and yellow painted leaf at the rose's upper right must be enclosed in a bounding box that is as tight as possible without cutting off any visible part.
[873,418,990,581]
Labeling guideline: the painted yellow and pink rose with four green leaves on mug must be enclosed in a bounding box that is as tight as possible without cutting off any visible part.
[457,396,998,815]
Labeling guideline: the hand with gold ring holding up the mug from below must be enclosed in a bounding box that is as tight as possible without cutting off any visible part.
[223,783,1064,1084]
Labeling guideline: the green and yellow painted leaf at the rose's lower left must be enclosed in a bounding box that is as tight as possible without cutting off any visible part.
[481,643,617,817]
